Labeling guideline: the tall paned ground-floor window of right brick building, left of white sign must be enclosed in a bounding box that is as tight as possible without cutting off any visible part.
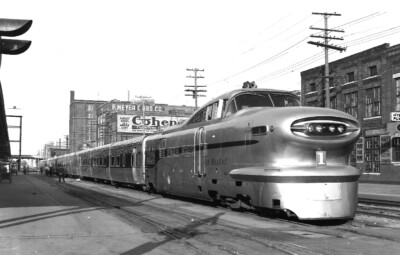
[364,136,381,173]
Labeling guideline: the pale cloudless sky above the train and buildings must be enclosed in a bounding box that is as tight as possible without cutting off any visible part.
[0,0,400,155]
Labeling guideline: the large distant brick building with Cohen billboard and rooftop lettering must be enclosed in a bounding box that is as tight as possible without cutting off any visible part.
[69,91,195,152]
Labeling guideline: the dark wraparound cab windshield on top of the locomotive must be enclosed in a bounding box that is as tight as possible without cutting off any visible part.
[226,92,300,117]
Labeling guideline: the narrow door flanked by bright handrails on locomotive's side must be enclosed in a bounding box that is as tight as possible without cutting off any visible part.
[193,127,207,192]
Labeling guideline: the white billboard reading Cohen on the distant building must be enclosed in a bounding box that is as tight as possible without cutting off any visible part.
[117,115,187,133]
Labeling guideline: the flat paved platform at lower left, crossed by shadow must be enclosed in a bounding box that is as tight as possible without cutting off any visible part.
[0,174,156,255]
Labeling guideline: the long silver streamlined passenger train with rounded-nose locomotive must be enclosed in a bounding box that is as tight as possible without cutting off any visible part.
[46,89,361,220]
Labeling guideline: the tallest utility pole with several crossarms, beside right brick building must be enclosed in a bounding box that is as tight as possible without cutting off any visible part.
[307,12,346,108]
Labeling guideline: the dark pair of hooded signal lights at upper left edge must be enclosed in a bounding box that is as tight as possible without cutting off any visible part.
[0,19,32,64]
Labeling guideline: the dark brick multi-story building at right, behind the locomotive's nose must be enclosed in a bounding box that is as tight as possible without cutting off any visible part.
[301,44,400,182]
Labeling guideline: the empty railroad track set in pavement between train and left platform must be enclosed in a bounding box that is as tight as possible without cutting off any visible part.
[45,177,328,255]
